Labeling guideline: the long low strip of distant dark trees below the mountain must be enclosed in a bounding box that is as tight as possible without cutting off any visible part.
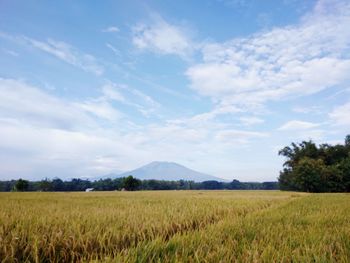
[0,175,278,192]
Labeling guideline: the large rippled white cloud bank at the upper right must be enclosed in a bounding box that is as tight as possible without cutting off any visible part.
[186,0,350,109]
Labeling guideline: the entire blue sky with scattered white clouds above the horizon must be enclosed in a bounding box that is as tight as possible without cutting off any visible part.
[0,0,350,181]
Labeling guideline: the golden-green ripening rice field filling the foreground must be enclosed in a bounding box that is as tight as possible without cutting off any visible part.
[0,191,350,262]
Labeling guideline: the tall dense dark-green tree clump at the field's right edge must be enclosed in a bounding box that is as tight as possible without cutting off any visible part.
[278,135,350,192]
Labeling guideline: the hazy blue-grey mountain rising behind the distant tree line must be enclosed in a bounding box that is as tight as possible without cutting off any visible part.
[116,162,225,182]
